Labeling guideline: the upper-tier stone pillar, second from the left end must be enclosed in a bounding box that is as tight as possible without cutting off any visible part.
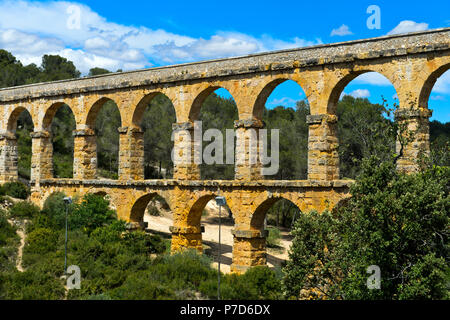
[31,131,53,183]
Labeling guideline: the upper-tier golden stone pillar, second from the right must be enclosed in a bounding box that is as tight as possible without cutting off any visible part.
[307,114,340,181]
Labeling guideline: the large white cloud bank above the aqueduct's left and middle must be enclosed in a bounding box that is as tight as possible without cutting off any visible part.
[0,0,322,74]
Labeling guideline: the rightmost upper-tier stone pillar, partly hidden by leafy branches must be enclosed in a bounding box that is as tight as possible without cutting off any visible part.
[395,108,433,173]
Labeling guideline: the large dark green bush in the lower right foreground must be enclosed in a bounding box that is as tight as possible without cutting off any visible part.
[284,159,450,299]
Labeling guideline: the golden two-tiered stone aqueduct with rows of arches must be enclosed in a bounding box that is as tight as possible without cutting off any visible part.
[0,28,450,272]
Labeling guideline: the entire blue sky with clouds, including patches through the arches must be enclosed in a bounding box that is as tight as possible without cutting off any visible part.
[0,0,450,122]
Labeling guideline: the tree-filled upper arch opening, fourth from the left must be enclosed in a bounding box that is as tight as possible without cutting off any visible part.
[133,93,177,179]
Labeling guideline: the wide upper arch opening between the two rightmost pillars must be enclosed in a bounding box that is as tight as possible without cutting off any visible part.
[328,71,399,179]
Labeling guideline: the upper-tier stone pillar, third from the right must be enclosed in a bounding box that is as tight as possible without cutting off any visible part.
[234,119,265,181]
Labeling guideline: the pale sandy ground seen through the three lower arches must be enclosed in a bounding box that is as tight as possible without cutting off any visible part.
[144,202,291,273]
